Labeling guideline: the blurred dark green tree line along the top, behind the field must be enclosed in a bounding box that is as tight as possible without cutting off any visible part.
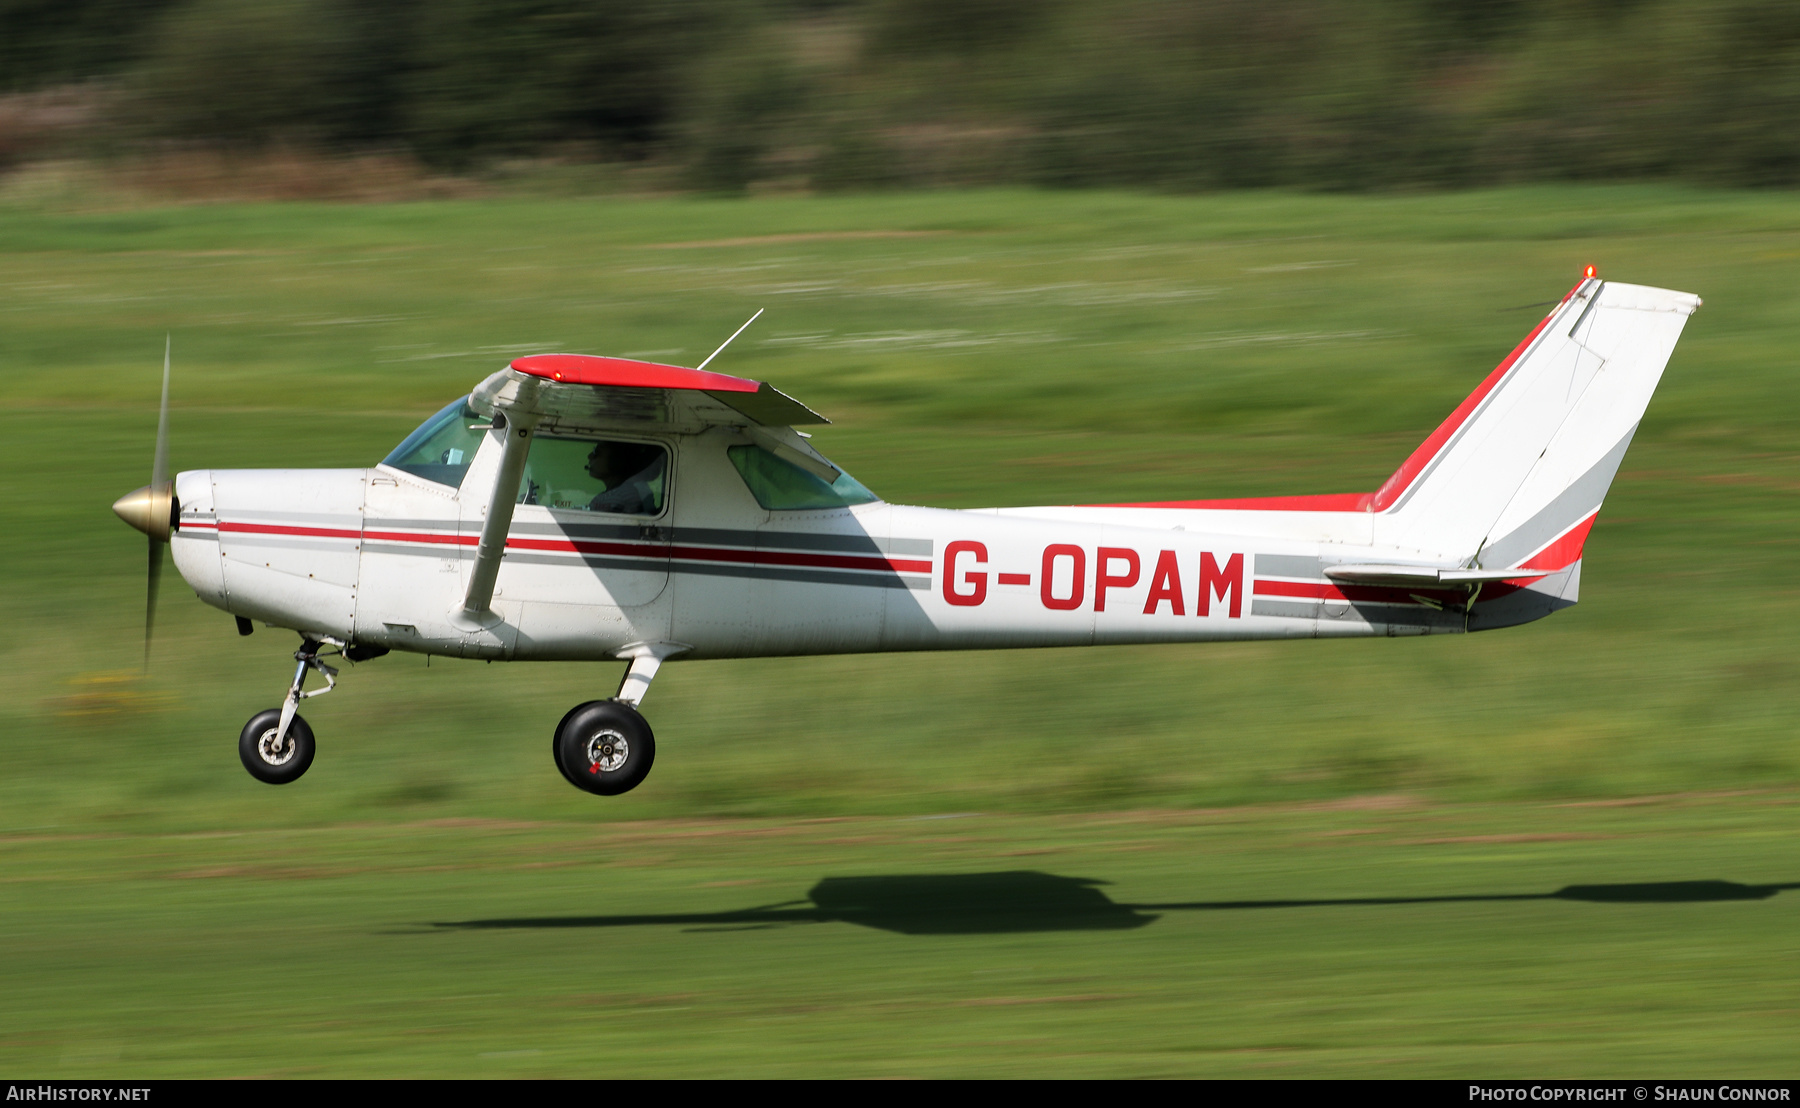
[0,0,1800,191]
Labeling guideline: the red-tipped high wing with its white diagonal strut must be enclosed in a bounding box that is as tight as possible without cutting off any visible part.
[454,354,841,626]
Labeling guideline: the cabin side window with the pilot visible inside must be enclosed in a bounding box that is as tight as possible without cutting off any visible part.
[518,435,670,516]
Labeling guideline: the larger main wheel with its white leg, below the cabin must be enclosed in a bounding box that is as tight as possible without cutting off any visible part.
[551,642,688,797]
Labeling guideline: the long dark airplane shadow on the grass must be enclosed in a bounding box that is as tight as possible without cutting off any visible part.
[434,871,1800,935]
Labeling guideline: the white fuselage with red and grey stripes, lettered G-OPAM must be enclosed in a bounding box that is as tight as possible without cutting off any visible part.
[173,417,1580,660]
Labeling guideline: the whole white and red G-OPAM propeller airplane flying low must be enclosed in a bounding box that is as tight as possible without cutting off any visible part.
[113,277,1701,795]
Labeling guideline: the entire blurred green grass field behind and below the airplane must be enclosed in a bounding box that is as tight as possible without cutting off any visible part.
[0,189,1800,1076]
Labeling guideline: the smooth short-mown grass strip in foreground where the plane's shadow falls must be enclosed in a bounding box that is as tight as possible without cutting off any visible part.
[0,791,1800,1077]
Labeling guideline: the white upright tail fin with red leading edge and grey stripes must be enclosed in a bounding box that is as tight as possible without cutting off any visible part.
[1370,277,1701,570]
